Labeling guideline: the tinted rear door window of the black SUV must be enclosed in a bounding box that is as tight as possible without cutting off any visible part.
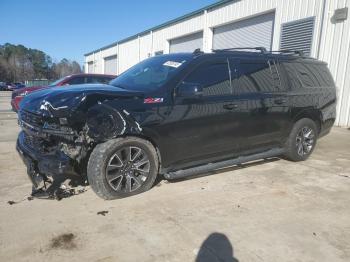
[233,61,280,94]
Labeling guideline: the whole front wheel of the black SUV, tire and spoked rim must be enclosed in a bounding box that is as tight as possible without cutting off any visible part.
[87,137,159,199]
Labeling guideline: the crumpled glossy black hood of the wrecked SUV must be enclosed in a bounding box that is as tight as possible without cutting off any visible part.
[20,84,142,116]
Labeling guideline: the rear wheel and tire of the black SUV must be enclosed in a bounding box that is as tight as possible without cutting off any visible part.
[285,118,318,162]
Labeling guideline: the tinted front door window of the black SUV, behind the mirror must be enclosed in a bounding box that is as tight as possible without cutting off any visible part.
[184,61,232,96]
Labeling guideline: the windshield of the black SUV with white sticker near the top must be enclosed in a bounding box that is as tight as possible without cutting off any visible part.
[110,55,190,91]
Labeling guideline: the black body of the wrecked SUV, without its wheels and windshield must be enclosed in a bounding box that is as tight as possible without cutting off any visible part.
[17,52,336,178]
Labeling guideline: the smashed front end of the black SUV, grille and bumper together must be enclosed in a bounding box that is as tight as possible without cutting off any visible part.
[17,110,92,188]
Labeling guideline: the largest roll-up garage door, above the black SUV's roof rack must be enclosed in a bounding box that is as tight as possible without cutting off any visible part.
[213,13,275,50]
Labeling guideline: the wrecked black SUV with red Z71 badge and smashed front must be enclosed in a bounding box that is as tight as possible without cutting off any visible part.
[17,48,336,199]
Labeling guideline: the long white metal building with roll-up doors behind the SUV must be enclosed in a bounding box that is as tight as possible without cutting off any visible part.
[85,0,350,126]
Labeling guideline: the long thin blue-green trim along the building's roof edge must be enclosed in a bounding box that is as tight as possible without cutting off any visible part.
[84,0,237,56]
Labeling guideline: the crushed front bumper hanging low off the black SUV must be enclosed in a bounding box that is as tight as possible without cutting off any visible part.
[16,131,77,188]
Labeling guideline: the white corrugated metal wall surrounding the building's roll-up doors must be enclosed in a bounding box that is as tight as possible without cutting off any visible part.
[85,0,350,126]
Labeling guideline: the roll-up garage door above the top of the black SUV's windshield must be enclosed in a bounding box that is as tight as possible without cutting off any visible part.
[170,32,203,53]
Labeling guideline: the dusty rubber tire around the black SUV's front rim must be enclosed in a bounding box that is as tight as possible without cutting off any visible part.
[87,137,159,200]
